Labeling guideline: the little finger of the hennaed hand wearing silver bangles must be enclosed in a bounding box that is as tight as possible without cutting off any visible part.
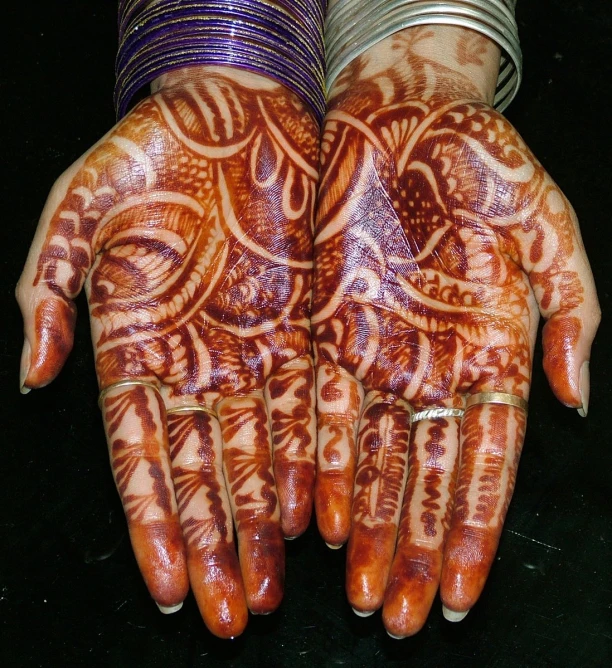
[315,362,363,547]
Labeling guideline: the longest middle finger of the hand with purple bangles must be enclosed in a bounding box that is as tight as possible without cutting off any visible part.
[168,412,248,638]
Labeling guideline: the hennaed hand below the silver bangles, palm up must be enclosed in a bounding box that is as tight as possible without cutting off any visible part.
[312,28,599,637]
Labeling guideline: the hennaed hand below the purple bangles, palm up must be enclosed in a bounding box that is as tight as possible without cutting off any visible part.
[17,68,318,637]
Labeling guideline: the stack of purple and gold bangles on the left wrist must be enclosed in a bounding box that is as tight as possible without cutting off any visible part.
[115,0,327,122]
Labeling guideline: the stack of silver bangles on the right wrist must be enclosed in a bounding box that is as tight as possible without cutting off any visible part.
[325,0,523,111]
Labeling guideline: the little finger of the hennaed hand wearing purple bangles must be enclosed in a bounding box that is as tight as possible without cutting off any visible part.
[265,357,316,538]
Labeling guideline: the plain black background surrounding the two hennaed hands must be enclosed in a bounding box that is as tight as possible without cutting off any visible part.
[0,0,612,668]
